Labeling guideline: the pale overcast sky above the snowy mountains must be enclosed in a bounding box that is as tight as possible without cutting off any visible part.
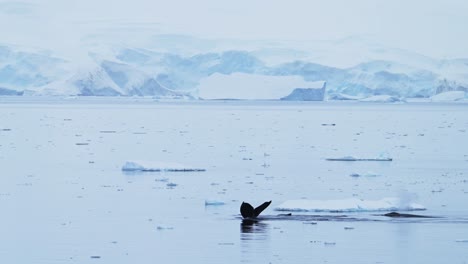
[0,0,468,58]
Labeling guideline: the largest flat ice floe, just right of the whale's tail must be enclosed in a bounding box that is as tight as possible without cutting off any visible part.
[275,197,426,212]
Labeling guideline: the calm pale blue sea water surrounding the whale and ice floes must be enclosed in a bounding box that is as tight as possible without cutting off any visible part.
[0,97,468,263]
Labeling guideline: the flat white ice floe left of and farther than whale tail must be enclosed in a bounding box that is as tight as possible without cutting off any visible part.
[122,161,206,172]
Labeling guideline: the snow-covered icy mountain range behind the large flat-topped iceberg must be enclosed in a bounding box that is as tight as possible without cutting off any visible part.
[0,42,468,98]
